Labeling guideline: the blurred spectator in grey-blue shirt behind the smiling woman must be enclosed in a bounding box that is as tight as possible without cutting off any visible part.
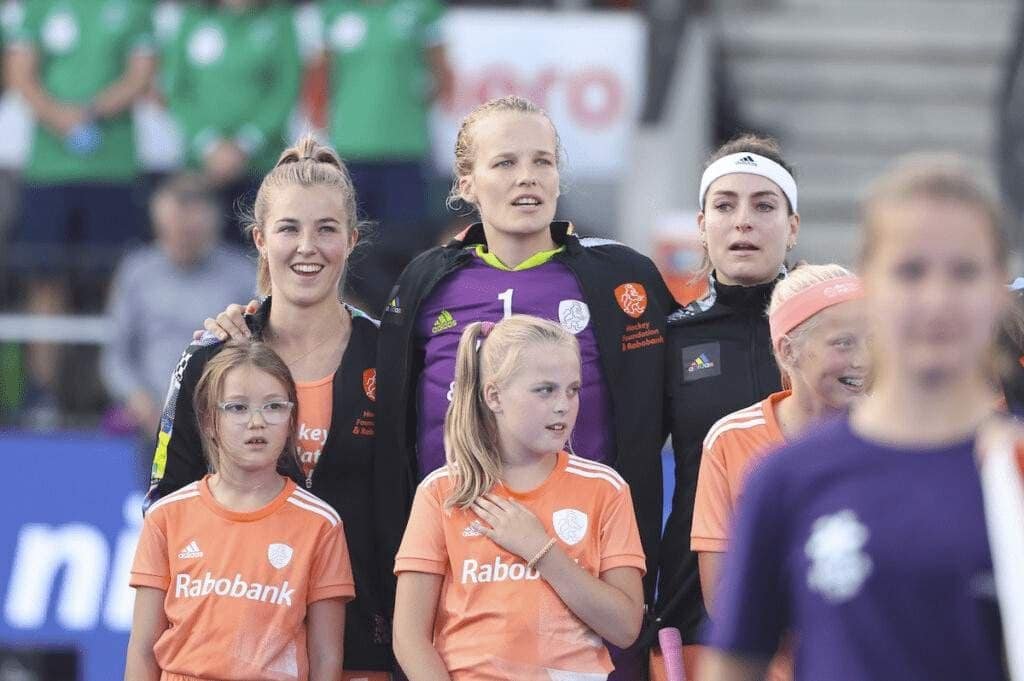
[101,174,256,436]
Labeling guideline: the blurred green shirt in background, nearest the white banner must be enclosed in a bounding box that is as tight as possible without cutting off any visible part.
[319,0,443,161]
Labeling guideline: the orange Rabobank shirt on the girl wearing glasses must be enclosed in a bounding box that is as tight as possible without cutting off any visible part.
[131,476,355,681]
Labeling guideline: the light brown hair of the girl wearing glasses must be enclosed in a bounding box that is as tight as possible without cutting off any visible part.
[193,340,299,472]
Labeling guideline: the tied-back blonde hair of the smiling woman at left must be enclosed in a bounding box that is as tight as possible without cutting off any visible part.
[245,135,359,296]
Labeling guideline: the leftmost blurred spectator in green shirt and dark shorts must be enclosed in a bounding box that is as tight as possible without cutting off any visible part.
[4,0,156,422]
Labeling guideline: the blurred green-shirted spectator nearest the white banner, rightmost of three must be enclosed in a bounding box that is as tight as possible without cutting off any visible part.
[319,0,453,314]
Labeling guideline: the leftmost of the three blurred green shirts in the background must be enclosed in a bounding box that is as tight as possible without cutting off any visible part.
[7,0,154,183]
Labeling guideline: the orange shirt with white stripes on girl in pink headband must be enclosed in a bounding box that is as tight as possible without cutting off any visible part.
[690,390,791,552]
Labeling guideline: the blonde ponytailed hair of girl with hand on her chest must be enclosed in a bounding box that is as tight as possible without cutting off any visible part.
[444,314,580,508]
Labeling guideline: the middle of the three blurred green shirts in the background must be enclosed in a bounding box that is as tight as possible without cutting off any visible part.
[163,2,302,173]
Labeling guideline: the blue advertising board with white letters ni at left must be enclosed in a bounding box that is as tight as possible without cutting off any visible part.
[0,432,142,681]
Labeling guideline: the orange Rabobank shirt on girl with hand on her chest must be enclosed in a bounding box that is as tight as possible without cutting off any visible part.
[394,452,645,681]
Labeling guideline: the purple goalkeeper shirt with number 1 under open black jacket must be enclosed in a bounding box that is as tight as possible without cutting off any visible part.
[416,248,614,477]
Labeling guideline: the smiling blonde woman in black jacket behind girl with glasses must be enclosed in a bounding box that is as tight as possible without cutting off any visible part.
[148,137,391,680]
